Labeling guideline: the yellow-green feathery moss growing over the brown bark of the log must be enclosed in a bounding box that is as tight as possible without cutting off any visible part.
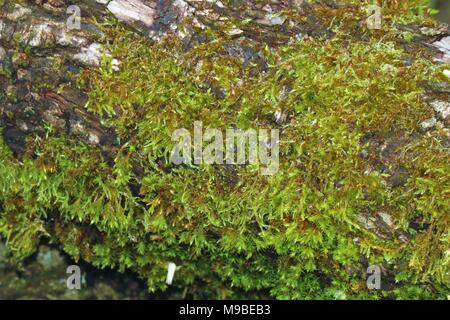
[0,1,450,299]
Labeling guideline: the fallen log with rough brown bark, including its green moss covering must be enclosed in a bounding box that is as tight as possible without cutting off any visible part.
[0,0,450,299]
